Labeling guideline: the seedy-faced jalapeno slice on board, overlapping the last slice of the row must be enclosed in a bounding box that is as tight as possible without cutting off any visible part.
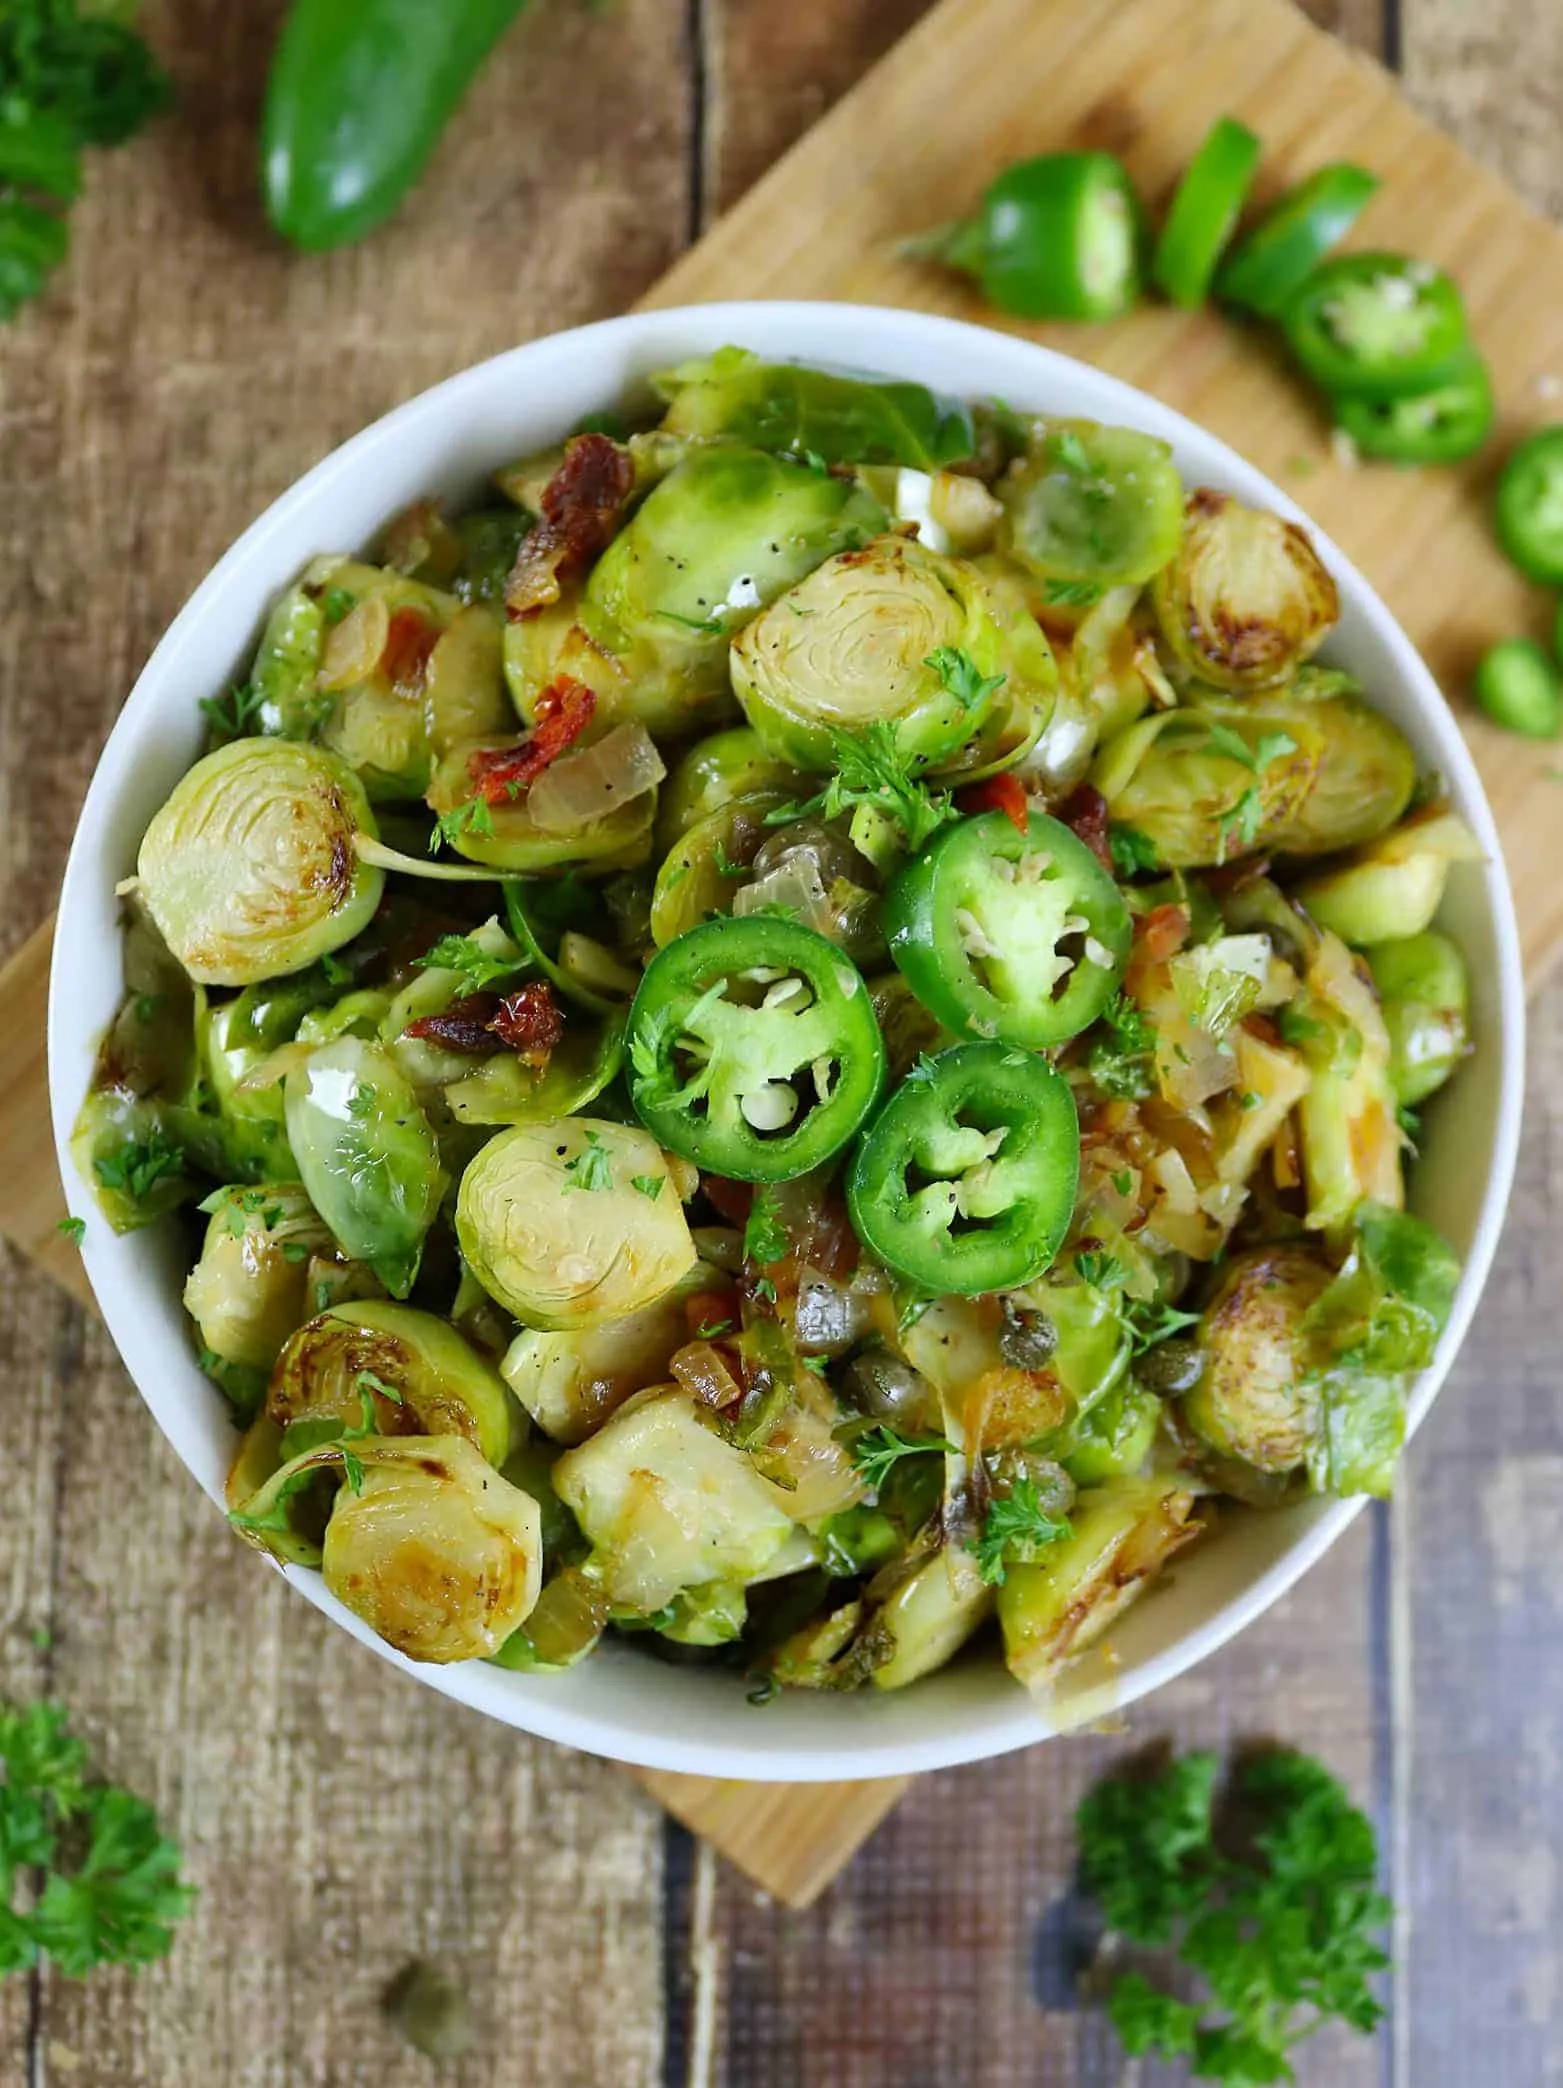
[1281,253,1469,399]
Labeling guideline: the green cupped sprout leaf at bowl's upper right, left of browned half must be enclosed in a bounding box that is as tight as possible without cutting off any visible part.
[997,420,1183,601]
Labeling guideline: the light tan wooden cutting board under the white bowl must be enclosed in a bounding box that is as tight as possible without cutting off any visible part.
[12,0,1563,1906]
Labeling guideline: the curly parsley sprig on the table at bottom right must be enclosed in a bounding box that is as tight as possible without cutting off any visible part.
[1075,1748,1392,2088]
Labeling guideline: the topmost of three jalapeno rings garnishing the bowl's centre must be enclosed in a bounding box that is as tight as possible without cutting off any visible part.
[885,812,1133,1050]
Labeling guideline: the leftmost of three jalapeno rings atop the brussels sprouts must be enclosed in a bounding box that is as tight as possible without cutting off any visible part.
[628,915,885,1182]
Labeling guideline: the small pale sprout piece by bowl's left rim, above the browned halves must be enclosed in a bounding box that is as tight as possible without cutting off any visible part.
[184,1182,338,1411]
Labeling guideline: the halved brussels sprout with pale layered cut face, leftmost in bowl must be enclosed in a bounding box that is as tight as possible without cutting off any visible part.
[138,739,384,986]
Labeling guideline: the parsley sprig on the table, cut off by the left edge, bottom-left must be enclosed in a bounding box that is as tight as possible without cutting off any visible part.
[0,1704,194,1979]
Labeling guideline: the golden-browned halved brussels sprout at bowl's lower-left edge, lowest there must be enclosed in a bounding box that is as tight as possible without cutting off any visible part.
[317,1437,543,1662]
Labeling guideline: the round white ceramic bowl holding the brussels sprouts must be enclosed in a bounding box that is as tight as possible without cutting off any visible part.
[48,303,1525,1781]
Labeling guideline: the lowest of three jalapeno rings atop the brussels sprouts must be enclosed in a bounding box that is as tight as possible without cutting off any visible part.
[847,1044,1081,1297]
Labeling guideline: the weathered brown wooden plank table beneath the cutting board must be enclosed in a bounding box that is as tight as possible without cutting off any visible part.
[0,0,1563,2088]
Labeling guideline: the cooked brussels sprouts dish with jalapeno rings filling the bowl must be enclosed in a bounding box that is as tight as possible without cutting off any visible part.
[75,349,1477,1700]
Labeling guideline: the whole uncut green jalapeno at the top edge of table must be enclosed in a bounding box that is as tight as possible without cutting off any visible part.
[261,0,526,253]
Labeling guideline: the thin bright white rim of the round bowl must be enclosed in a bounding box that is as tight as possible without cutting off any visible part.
[48,301,1525,1783]
